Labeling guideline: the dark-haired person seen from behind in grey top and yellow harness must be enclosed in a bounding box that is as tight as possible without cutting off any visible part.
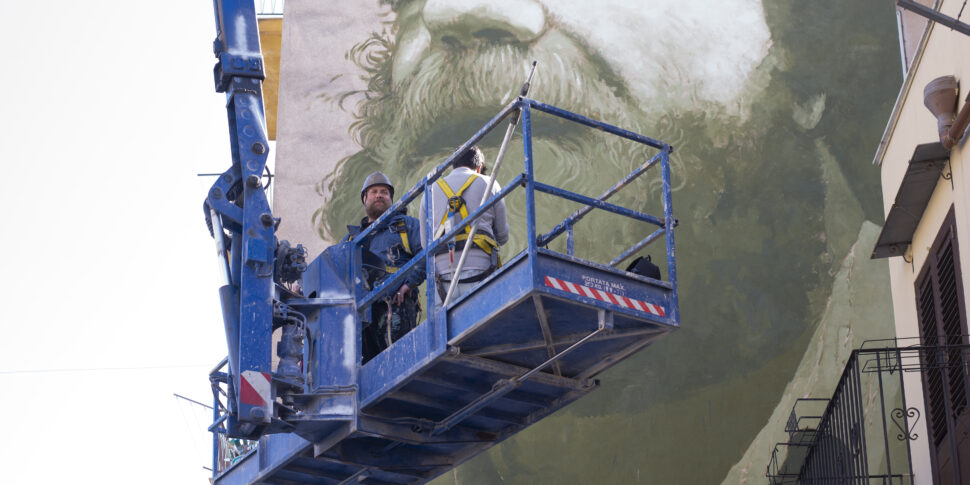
[418,146,509,304]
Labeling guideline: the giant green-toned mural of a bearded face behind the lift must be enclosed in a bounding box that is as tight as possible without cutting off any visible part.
[315,0,899,483]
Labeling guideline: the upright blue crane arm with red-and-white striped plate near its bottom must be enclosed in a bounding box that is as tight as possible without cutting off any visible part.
[203,0,276,437]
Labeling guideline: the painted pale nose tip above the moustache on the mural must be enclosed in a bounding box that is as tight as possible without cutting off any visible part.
[423,0,546,47]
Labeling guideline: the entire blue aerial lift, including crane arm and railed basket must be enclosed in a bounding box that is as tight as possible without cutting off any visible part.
[205,0,679,485]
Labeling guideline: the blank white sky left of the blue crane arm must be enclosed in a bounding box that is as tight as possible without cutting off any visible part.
[0,0,250,484]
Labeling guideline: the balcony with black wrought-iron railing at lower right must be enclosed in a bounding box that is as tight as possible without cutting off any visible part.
[765,338,970,485]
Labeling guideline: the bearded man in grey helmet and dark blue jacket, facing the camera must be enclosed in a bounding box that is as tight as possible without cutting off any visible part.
[344,172,425,362]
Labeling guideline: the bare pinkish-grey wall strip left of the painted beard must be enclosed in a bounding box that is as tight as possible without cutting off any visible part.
[273,0,387,256]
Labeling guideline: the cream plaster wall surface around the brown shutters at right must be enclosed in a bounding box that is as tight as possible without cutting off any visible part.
[881,0,970,484]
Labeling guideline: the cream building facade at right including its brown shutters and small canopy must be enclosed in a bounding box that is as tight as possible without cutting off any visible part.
[873,0,970,483]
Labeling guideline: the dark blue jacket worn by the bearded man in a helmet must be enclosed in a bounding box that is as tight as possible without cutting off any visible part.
[343,212,425,290]
